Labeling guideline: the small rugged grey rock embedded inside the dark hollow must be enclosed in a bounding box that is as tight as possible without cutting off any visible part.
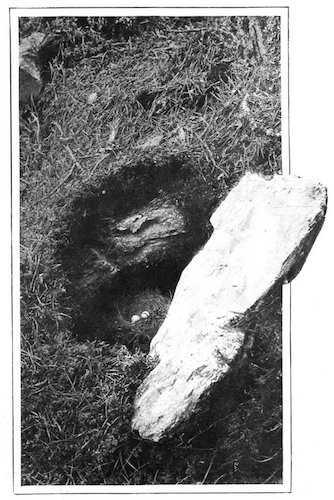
[78,198,191,294]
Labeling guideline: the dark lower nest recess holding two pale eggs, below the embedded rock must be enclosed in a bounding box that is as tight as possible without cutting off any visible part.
[73,262,184,352]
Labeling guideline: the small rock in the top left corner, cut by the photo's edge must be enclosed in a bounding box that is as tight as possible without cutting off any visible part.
[20,32,45,102]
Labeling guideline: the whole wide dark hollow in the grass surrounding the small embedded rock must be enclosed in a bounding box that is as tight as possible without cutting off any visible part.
[58,155,217,351]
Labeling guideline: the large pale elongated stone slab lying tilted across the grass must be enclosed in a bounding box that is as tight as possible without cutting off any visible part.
[132,174,327,441]
